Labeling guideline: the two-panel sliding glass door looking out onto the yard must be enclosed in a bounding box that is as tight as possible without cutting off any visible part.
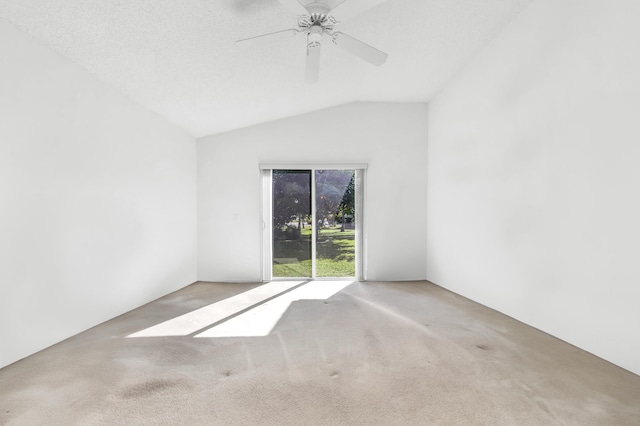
[263,168,363,280]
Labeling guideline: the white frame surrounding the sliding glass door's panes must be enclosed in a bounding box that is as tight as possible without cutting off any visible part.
[259,163,368,282]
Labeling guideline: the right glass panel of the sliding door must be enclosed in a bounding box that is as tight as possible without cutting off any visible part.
[315,170,356,277]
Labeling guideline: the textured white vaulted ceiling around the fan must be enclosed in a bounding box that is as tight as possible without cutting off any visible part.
[0,0,531,137]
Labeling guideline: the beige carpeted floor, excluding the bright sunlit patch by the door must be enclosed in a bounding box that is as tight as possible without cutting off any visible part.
[0,282,640,425]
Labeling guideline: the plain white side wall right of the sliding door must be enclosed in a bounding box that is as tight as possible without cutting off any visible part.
[427,0,640,373]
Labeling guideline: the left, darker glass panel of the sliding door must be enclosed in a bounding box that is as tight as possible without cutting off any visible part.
[272,170,313,277]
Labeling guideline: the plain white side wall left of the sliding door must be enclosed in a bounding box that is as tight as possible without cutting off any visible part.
[0,20,196,367]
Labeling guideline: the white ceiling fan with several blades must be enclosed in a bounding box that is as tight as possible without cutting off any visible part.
[236,0,388,83]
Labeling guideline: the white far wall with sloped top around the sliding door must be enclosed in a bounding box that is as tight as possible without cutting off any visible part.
[198,103,427,281]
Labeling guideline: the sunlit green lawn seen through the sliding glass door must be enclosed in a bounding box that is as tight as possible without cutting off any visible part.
[273,225,355,277]
